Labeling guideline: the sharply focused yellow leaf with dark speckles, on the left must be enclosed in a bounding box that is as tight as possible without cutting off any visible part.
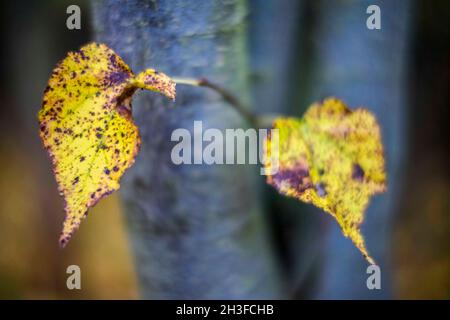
[38,43,175,246]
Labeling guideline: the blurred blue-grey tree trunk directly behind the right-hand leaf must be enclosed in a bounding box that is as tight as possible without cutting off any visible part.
[311,0,413,299]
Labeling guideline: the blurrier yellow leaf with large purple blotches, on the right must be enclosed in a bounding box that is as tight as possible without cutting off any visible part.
[265,98,386,264]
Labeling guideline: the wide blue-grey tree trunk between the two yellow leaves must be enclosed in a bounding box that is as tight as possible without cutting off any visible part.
[93,0,281,299]
